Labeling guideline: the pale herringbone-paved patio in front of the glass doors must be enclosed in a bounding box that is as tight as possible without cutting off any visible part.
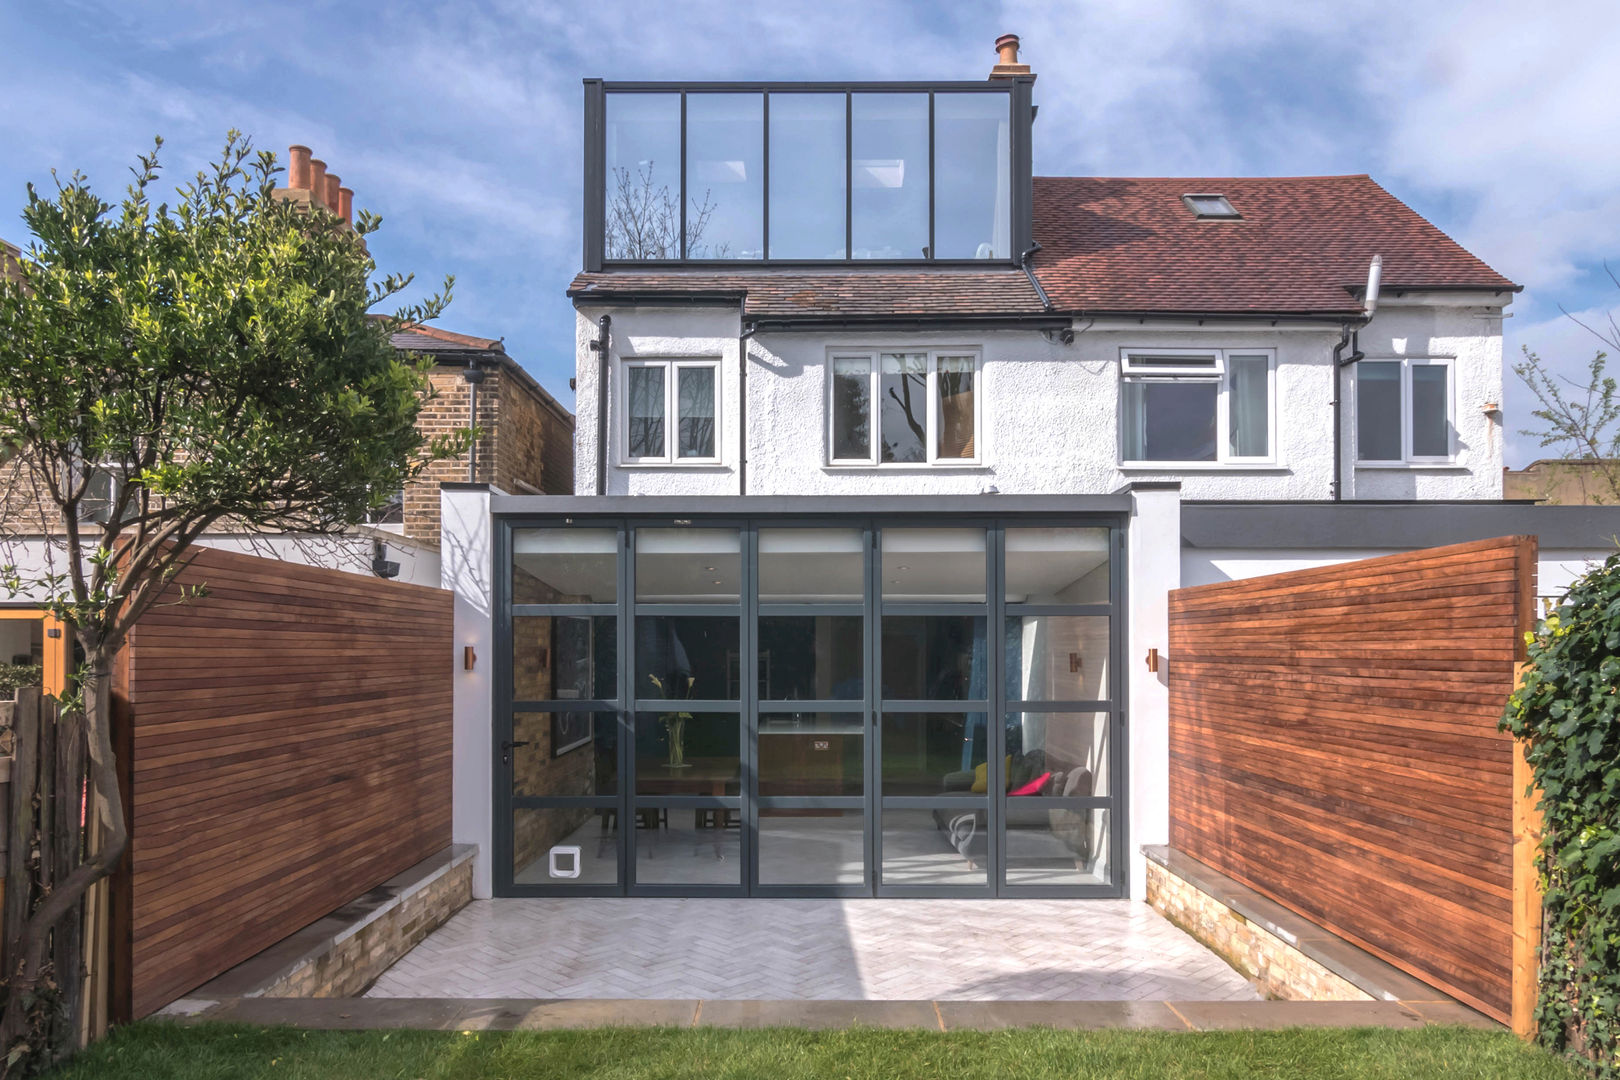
[366,899,1260,1002]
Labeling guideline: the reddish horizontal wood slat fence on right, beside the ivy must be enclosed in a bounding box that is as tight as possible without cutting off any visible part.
[1170,536,1536,1020]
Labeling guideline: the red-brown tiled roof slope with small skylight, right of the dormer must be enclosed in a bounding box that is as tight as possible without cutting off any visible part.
[1034,176,1516,314]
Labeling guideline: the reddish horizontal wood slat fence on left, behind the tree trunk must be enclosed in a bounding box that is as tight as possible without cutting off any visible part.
[112,549,454,1017]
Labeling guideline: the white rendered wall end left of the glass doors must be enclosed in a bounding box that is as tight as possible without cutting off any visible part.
[439,484,496,900]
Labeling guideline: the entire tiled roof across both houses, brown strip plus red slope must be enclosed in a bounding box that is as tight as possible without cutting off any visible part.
[569,176,1518,319]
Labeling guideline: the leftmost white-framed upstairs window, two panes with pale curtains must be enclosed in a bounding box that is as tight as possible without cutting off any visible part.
[619,359,719,465]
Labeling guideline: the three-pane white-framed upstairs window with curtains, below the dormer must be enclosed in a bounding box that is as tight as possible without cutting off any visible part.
[826,348,983,465]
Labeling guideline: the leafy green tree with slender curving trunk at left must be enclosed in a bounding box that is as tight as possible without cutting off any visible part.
[0,131,470,1056]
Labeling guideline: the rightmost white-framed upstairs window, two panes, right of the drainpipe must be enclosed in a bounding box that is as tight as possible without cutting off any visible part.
[1356,356,1456,465]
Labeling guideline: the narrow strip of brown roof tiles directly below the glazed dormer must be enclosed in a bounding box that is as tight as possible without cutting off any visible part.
[569,267,1043,317]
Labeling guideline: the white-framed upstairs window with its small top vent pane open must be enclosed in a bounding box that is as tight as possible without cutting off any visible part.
[1119,348,1277,468]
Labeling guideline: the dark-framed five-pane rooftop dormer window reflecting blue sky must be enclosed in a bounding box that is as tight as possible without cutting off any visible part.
[586,83,1029,262]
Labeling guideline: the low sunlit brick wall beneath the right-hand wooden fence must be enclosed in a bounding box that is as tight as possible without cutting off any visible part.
[1147,861,1372,1001]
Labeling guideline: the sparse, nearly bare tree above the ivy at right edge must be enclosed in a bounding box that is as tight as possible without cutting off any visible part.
[1513,270,1620,504]
